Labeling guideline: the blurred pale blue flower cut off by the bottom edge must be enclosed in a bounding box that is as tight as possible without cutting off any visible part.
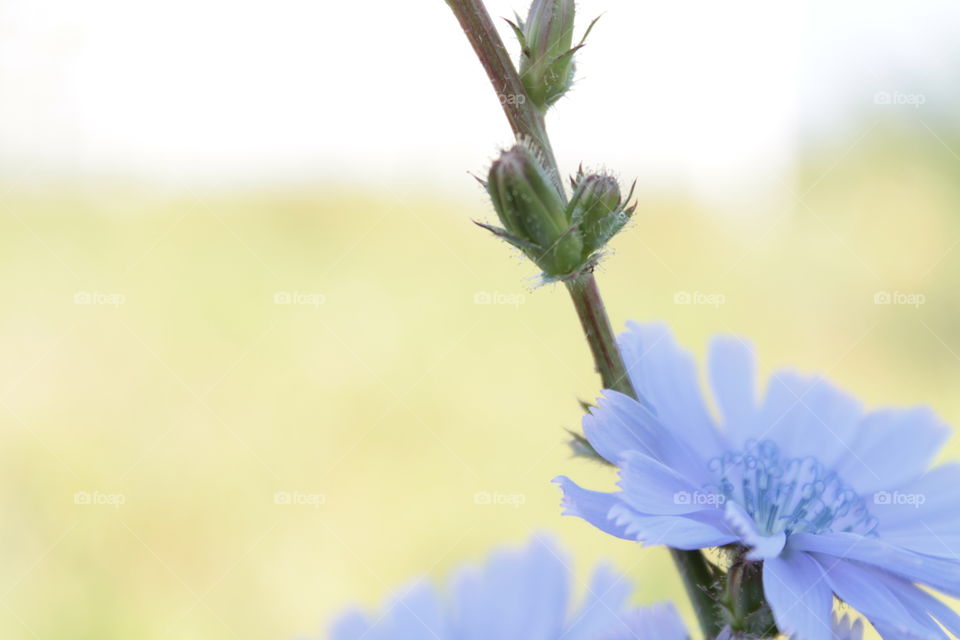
[330,537,689,640]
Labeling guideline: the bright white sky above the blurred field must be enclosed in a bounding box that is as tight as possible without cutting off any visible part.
[0,0,960,202]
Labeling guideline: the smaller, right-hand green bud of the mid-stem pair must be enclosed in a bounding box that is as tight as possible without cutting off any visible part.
[569,170,635,253]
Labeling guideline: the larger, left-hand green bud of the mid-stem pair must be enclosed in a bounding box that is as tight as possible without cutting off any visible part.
[483,145,584,277]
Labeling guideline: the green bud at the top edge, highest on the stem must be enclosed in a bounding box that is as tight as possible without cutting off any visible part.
[514,0,579,112]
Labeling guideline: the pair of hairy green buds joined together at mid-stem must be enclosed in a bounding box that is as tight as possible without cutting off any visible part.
[481,144,634,278]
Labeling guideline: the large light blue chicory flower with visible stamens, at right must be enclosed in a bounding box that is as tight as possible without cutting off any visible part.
[557,324,960,640]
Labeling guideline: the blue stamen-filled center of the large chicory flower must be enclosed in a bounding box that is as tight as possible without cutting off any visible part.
[708,440,877,536]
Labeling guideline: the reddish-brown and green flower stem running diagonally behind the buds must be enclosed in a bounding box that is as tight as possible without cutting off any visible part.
[446,0,721,638]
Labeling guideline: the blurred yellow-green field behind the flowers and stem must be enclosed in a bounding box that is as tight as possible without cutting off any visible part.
[0,126,960,640]
